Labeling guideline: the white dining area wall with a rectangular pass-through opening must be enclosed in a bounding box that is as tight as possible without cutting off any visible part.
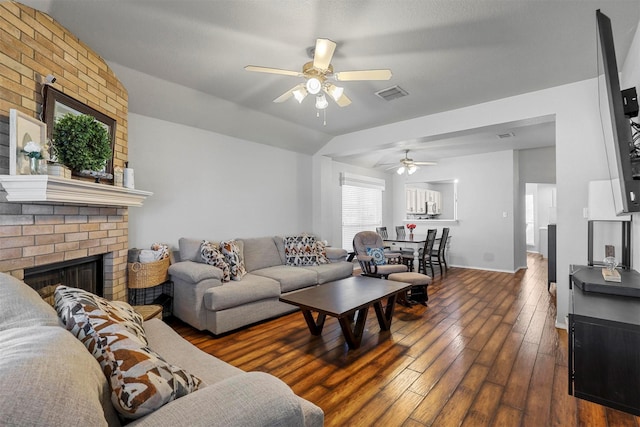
[393,151,514,272]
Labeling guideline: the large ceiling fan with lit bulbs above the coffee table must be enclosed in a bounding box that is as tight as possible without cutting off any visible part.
[244,39,391,110]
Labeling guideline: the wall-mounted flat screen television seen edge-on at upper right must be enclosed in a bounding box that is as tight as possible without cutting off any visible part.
[596,10,640,215]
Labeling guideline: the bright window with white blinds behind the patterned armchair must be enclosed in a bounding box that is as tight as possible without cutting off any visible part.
[342,173,384,251]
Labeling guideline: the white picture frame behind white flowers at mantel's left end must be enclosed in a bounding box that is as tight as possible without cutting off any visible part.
[9,108,47,175]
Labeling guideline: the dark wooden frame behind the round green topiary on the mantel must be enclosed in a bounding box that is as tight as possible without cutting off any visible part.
[42,84,117,181]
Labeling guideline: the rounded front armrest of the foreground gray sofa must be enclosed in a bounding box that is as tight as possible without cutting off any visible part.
[129,372,304,427]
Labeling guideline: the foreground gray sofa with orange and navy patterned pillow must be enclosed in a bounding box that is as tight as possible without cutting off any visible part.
[0,273,324,426]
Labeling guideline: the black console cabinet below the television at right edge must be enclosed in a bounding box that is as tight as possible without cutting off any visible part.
[569,266,640,416]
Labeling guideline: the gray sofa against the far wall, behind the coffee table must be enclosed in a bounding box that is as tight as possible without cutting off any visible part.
[169,236,353,334]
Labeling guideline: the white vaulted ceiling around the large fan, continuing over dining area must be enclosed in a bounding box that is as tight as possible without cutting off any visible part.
[23,0,640,168]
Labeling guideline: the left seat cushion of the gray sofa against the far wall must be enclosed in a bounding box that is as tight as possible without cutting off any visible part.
[204,273,280,311]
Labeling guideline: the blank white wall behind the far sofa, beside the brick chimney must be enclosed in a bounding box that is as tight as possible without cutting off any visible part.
[129,113,313,248]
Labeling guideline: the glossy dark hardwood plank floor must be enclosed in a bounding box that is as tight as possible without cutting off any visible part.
[170,255,640,427]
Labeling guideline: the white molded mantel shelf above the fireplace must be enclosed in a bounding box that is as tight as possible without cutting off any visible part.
[0,175,153,206]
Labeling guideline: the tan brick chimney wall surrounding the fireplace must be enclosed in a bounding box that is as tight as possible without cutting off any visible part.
[0,1,129,300]
